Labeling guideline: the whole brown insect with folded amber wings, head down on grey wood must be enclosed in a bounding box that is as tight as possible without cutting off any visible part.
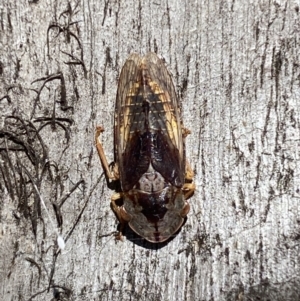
[95,53,195,243]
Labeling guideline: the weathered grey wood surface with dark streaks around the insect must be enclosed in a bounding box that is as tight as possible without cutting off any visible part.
[0,0,300,301]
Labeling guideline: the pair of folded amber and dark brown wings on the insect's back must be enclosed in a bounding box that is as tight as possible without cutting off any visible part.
[115,53,185,191]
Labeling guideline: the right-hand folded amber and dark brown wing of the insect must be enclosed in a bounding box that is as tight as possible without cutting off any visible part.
[142,52,185,187]
